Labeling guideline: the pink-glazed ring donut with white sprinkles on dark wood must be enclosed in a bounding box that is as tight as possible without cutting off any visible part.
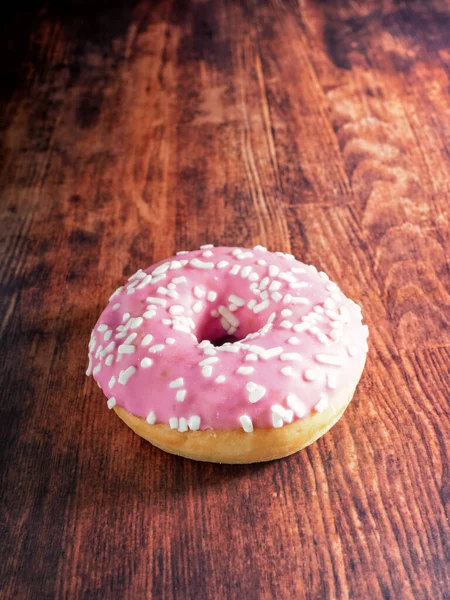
[87,245,368,463]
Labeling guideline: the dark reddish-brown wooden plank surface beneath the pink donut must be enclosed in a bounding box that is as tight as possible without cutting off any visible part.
[0,0,450,600]
